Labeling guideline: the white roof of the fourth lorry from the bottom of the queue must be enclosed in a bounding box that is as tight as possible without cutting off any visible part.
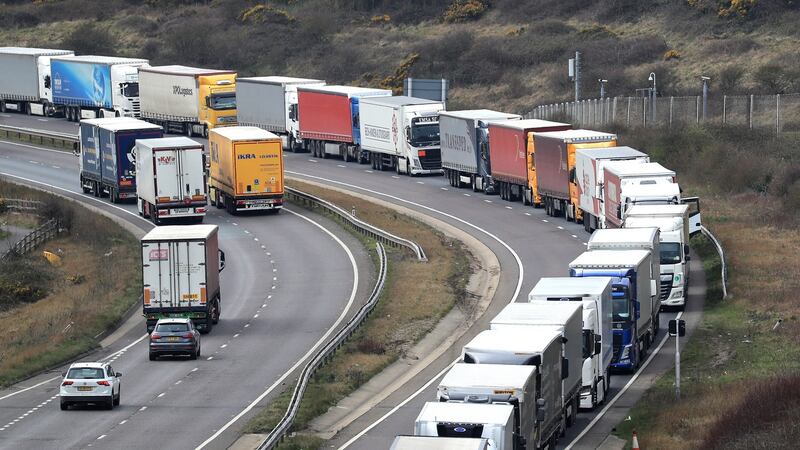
[464,326,564,356]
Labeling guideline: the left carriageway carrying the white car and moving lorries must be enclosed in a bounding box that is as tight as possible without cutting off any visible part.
[0,118,373,449]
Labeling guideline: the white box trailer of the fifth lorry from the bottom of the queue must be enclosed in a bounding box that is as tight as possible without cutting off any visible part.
[489,302,583,426]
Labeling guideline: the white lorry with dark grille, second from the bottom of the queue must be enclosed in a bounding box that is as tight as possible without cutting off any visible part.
[414,402,521,450]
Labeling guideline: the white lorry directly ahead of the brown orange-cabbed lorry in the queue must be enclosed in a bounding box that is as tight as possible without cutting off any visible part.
[575,147,650,233]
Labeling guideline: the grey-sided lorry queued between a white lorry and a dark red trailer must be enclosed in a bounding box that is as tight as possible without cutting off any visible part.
[439,109,521,194]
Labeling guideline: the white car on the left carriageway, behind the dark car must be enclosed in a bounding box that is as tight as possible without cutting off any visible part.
[60,362,122,411]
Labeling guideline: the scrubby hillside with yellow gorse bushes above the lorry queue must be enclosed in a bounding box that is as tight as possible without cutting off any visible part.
[6,0,800,112]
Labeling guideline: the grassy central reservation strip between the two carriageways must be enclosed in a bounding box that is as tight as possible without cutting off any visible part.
[243,182,473,450]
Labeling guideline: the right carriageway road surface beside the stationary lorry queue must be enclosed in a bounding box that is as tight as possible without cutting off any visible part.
[2,115,702,450]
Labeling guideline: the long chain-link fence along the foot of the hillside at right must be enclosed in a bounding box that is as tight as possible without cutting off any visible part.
[525,94,800,133]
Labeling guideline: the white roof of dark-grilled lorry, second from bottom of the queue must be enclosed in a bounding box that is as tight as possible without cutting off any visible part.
[417,402,514,425]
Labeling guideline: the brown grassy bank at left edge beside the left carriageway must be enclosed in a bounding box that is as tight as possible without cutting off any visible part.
[0,181,141,386]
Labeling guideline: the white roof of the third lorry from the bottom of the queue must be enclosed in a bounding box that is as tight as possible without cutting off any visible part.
[439,363,536,389]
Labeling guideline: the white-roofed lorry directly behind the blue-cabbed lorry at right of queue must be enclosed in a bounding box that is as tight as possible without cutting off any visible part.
[586,227,662,330]
